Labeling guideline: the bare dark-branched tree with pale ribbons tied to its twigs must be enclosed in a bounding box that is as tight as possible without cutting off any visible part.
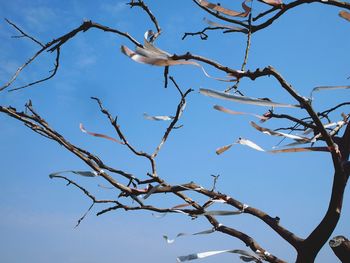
[0,0,350,263]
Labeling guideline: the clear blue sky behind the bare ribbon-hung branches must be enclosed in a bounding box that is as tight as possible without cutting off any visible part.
[0,0,350,263]
